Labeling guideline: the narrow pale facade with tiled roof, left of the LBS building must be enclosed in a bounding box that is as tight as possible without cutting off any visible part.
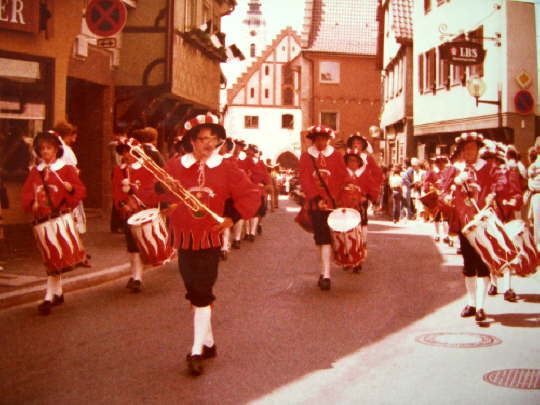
[377,0,416,164]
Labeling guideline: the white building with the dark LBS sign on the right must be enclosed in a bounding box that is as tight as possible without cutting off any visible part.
[413,0,537,158]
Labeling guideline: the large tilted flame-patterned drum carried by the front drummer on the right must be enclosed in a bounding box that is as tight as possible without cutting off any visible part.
[461,208,518,277]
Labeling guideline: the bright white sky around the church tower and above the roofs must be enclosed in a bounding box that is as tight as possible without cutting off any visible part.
[221,0,304,88]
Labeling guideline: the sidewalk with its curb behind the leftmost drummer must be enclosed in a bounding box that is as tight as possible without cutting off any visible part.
[0,215,129,309]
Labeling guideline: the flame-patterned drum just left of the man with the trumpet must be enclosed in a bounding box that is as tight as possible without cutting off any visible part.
[127,208,174,266]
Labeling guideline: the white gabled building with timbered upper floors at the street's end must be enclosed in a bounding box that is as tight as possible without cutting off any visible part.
[224,27,302,162]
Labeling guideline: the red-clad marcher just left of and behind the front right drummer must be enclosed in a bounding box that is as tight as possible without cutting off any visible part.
[422,155,452,246]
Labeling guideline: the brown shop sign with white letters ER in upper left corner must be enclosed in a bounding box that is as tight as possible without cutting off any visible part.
[0,0,39,33]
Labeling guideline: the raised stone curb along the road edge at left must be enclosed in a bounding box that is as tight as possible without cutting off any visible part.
[0,263,130,310]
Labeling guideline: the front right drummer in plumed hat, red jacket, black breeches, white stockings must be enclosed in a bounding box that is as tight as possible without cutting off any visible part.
[441,132,506,322]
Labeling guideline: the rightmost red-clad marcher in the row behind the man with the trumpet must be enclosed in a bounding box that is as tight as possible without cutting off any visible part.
[241,144,272,242]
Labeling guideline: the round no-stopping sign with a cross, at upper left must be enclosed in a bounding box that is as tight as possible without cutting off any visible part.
[85,0,127,37]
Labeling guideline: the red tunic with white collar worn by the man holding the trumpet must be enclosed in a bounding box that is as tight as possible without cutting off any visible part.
[165,153,260,250]
